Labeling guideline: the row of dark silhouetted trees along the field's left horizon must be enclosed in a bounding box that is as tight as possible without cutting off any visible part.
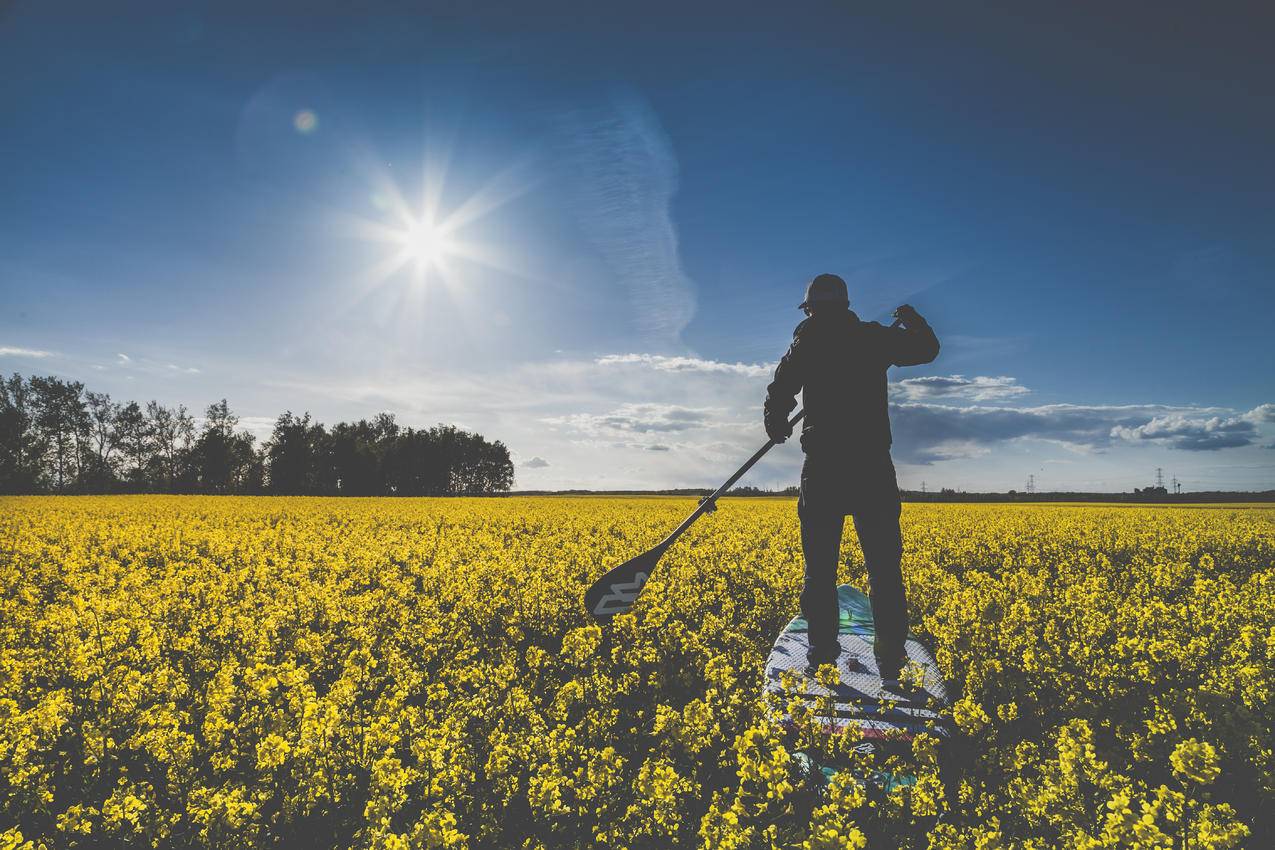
[0,373,514,496]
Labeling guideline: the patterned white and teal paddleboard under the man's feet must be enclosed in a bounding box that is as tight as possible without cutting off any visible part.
[764,585,951,779]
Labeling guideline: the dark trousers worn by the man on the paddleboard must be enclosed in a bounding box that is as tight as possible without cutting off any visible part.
[797,454,908,666]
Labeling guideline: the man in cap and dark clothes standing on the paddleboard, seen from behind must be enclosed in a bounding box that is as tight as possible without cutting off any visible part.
[765,274,938,684]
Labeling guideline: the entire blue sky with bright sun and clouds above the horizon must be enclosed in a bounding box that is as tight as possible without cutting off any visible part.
[0,0,1275,491]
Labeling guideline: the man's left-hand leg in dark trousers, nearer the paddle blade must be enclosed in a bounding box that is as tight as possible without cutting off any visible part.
[797,493,845,664]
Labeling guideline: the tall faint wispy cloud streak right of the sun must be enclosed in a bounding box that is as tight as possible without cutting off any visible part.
[558,94,695,344]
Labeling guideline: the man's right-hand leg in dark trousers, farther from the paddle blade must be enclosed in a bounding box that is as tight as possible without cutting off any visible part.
[854,501,908,678]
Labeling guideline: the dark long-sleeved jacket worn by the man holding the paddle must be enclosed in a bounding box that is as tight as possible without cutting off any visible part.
[765,310,938,455]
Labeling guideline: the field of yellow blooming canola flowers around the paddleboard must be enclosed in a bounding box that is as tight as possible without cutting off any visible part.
[0,497,1275,850]
